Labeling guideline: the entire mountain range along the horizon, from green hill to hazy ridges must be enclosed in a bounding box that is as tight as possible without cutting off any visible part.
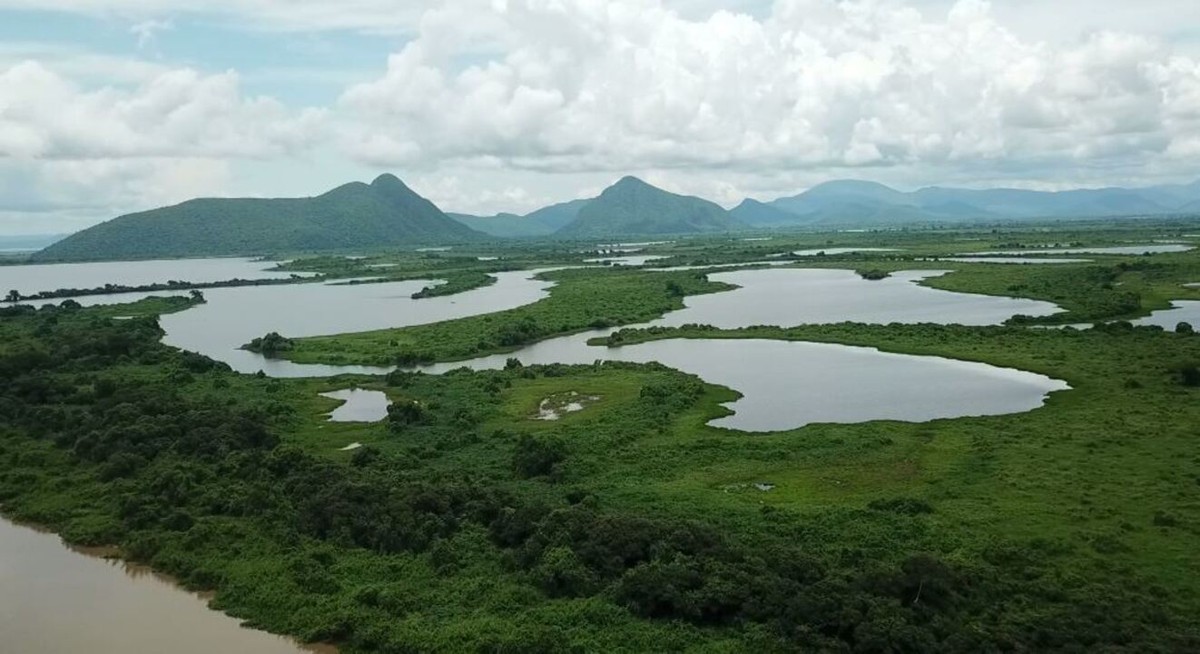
[34,175,1200,260]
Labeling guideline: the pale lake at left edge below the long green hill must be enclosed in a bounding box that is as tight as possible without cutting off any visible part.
[0,258,300,294]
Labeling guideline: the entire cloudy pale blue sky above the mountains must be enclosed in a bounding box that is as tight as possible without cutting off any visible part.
[0,0,1200,234]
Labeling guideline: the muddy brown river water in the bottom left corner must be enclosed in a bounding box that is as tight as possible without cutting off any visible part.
[0,518,311,654]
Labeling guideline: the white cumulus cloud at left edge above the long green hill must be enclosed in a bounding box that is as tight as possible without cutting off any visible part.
[0,61,324,232]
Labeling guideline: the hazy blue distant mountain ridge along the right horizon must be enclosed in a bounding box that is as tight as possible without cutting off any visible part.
[753,180,1200,226]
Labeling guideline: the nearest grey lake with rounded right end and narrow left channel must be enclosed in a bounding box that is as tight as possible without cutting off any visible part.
[416,332,1069,432]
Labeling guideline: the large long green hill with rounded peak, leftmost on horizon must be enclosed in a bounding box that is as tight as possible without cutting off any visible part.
[34,175,486,262]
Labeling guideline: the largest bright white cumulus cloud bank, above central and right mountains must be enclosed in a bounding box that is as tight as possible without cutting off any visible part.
[338,0,1200,186]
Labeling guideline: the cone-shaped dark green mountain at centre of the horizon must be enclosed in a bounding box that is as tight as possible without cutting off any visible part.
[557,176,745,238]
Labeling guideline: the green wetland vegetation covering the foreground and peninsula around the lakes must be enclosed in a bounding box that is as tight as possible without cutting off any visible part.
[7,229,1200,653]
